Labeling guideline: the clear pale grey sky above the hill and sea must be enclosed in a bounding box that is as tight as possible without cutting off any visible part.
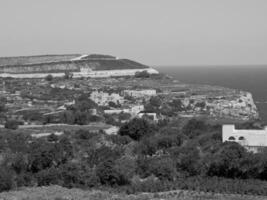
[0,0,267,66]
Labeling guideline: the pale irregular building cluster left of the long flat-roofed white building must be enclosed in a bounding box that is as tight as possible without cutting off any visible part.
[90,91,124,106]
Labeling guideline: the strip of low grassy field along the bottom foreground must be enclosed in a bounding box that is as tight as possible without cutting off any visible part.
[0,186,267,200]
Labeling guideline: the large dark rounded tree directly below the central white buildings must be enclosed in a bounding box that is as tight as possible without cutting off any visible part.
[119,118,153,140]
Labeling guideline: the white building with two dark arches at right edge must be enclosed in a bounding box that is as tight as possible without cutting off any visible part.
[222,125,267,152]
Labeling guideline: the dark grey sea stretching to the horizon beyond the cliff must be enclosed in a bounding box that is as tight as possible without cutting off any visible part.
[154,66,267,124]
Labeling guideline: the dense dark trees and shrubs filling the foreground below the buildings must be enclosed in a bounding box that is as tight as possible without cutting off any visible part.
[0,119,267,195]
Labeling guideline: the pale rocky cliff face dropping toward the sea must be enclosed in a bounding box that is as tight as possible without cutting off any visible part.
[182,91,259,120]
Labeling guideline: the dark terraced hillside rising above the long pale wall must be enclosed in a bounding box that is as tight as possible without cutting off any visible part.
[0,54,149,74]
